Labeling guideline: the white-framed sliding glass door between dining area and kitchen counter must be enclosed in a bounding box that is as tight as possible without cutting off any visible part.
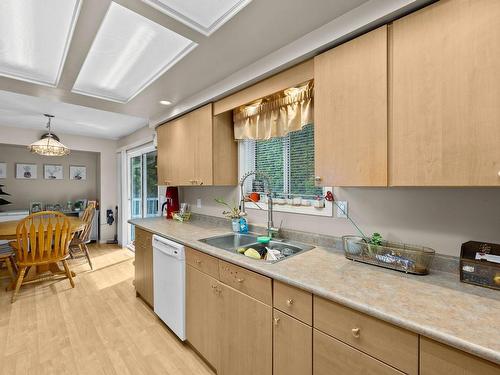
[127,146,158,246]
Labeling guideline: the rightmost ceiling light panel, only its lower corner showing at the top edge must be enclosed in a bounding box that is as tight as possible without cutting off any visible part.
[142,0,252,36]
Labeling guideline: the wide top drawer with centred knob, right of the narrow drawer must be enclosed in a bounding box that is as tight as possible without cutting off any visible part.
[314,297,418,375]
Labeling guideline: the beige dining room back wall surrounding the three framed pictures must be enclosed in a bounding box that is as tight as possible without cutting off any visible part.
[0,144,98,210]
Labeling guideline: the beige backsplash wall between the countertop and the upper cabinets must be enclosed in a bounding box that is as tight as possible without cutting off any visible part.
[182,187,500,256]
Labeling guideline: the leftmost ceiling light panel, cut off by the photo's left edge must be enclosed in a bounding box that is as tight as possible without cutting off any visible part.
[0,0,81,86]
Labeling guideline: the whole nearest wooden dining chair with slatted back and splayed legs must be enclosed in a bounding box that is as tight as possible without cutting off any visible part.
[10,211,75,303]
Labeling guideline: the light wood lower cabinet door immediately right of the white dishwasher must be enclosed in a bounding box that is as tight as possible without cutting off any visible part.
[186,266,219,368]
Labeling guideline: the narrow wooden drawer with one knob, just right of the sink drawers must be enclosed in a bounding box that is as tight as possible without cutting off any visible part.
[273,281,312,325]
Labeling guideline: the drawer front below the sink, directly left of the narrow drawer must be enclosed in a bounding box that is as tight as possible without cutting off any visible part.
[219,260,272,306]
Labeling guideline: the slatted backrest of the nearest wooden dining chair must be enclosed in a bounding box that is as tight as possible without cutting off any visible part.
[16,211,71,264]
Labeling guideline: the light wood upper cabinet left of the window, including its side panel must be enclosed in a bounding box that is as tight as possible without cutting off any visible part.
[157,104,238,186]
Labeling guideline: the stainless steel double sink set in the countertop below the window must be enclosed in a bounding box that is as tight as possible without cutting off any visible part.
[200,233,314,263]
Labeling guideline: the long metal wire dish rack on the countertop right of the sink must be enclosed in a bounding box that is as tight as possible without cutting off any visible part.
[342,236,436,275]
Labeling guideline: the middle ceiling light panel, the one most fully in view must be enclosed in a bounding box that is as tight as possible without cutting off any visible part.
[72,2,197,103]
